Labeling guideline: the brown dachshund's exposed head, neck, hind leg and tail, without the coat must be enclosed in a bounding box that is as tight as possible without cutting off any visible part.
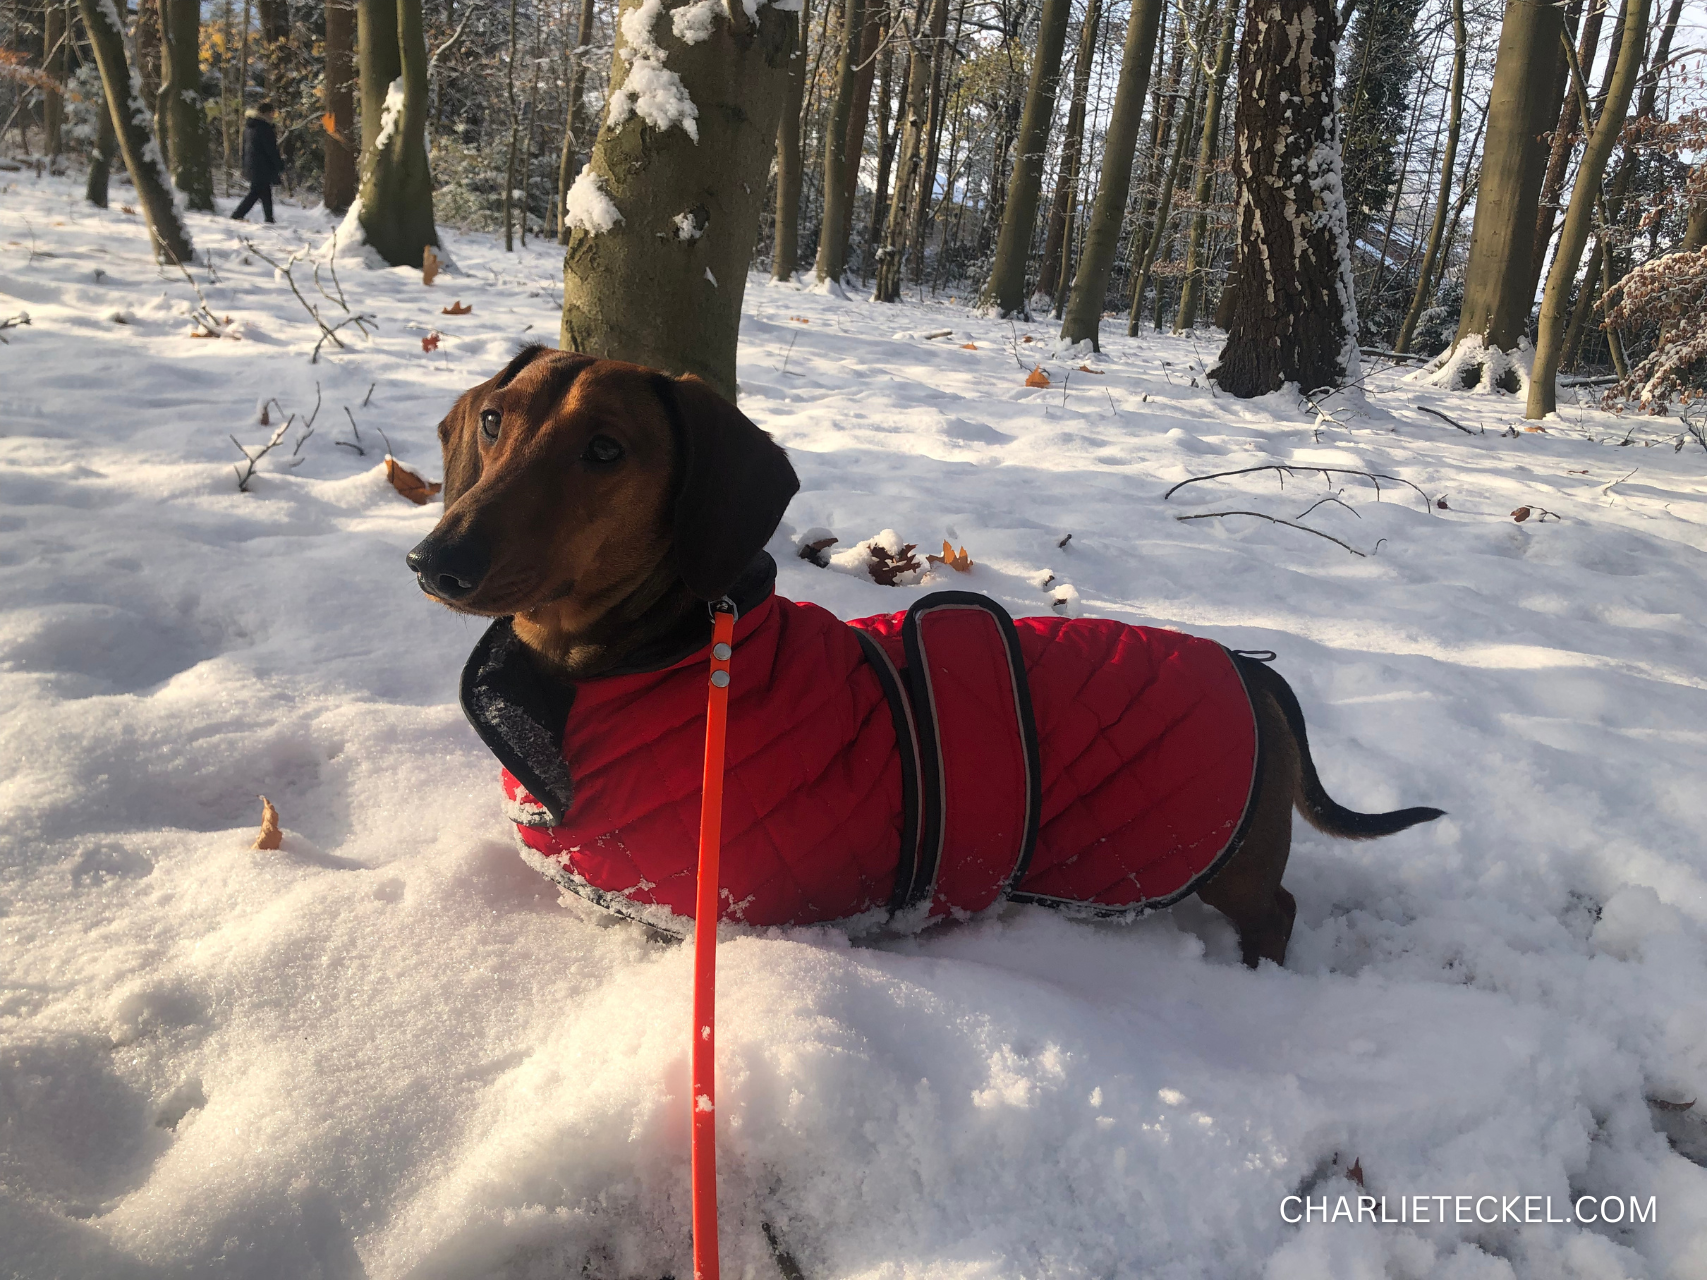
[408,346,1441,966]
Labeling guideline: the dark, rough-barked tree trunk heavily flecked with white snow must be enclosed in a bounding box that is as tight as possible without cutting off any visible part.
[1209,0,1357,399]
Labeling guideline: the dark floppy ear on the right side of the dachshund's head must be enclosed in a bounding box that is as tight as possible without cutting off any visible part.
[657,374,801,601]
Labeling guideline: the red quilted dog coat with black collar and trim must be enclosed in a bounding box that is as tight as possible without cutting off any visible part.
[463,556,1256,932]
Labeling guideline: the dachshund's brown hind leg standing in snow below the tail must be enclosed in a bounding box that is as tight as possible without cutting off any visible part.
[1197,695,1299,969]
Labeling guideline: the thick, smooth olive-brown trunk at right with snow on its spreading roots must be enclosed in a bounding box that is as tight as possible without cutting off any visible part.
[1453,0,1564,391]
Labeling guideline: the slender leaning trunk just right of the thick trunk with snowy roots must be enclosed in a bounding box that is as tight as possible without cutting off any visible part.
[1524,0,1649,418]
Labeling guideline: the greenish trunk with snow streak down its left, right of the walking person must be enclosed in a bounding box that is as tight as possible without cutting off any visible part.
[357,0,439,266]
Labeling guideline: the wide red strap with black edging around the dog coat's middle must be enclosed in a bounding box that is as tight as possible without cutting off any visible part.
[901,591,1043,916]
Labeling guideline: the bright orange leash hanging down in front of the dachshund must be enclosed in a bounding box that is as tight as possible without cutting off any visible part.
[691,597,736,1280]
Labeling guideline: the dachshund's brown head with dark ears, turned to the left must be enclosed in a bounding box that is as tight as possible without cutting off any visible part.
[408,346,799,633]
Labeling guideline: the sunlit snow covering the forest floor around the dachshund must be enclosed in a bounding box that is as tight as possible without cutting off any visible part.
[0,174,1707,1280]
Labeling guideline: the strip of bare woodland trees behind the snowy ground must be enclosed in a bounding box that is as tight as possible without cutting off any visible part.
[0,0,1707,418]
